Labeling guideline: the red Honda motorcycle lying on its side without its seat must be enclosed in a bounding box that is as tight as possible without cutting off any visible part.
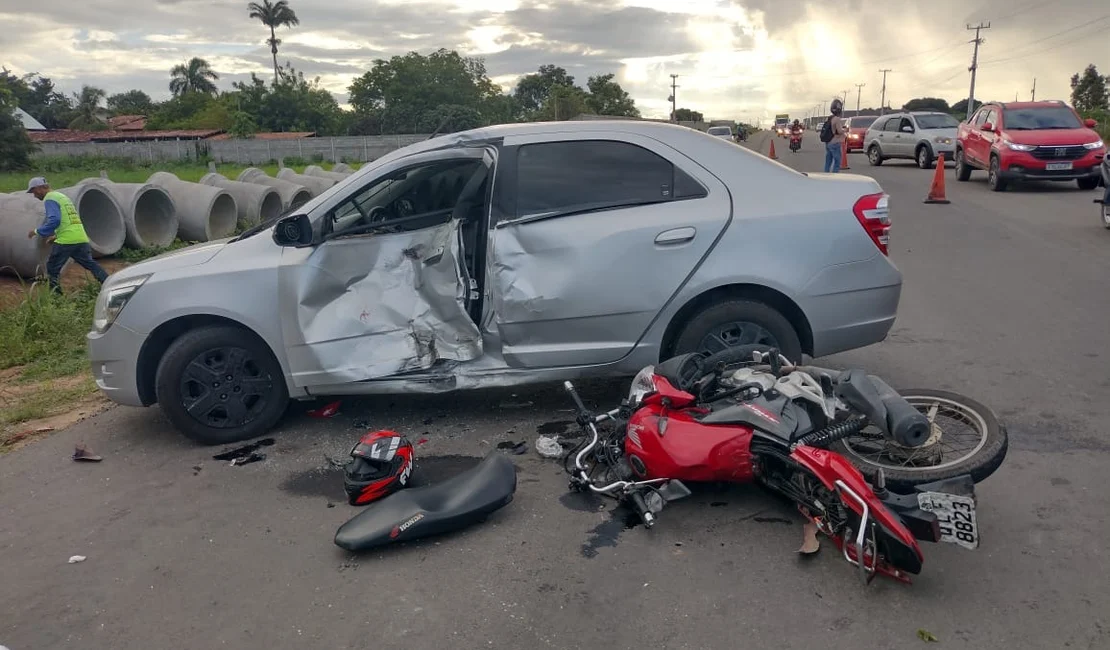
[564,346,1008,583]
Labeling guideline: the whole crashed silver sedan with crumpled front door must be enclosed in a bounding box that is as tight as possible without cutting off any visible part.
[88,121,902,444]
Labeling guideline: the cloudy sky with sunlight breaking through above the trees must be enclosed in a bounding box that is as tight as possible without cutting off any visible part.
[0,0,1110,123]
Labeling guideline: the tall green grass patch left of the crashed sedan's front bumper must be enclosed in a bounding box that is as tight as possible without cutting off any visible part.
[0,278,100,380]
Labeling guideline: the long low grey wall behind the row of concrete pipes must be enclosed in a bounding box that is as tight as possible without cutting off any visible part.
[37,134,430,164]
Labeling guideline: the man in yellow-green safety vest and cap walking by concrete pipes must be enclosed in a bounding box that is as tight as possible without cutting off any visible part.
[27,176,108,293]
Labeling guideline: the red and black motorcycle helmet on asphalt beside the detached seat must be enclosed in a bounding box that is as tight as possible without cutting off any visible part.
[343,430,413,506]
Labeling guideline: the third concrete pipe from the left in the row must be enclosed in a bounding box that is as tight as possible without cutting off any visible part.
[81,179,179,248]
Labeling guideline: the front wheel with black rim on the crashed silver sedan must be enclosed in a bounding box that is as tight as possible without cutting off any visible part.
[154,325,290,445]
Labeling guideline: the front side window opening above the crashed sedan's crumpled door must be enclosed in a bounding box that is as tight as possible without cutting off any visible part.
[329,159,483,234]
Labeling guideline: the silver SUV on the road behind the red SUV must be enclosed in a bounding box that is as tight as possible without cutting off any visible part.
[864,111,960,170]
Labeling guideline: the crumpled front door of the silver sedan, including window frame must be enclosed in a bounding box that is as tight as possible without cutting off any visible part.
[280,148,494,387]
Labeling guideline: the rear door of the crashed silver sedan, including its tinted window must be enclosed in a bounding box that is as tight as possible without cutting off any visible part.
[490,132,733,368]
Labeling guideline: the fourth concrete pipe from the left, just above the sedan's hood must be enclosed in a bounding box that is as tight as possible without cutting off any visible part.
[147,172,239,242]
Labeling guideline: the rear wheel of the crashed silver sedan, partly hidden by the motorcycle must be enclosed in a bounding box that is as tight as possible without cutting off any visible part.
[670,299,801,363]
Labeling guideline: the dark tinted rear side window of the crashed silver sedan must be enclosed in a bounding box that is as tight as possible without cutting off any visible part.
[515,140,707,217]
